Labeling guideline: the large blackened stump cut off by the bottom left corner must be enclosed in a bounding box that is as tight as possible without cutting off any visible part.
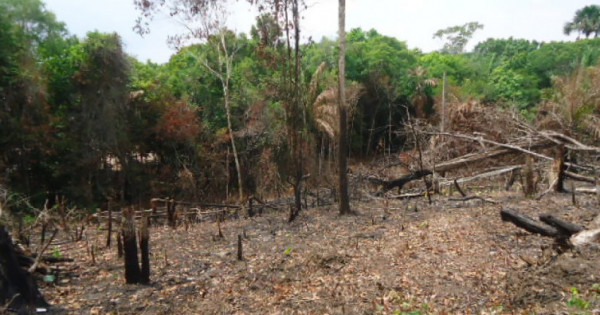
[0,225,50,314]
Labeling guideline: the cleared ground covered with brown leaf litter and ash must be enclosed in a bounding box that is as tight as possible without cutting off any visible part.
[41,188,600,314]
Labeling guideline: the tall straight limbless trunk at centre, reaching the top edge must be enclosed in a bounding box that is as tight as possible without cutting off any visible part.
[338,0,350,215]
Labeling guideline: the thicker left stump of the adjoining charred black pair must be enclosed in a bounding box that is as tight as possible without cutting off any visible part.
[122,208,141,283]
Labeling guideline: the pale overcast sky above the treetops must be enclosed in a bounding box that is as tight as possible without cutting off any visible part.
[43,0,599,63]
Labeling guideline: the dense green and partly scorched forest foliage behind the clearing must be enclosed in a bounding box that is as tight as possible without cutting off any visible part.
[0,0,600,214]
